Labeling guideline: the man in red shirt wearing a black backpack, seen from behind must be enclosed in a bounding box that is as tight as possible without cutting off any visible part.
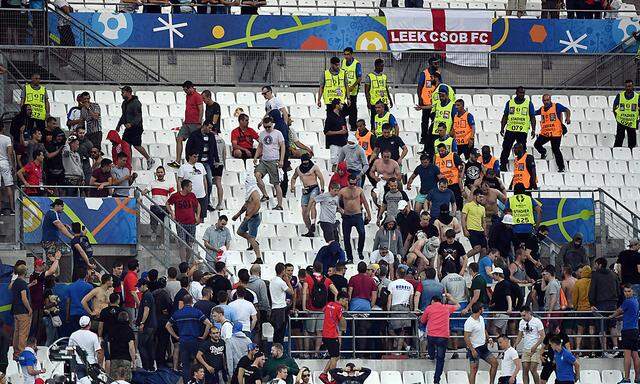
[302,261,338,352]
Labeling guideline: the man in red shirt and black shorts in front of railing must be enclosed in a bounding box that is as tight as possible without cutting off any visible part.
[318,292,349,384]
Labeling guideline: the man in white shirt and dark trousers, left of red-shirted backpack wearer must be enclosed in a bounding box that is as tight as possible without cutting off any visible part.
[269,263,293,344]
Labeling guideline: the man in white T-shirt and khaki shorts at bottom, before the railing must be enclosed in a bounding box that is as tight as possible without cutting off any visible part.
[515,306,545,384]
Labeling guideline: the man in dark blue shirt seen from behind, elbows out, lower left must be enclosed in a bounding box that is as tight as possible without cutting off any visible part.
[165,295,212,383]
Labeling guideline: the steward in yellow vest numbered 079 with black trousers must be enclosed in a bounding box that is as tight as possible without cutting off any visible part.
[500,87,536,171]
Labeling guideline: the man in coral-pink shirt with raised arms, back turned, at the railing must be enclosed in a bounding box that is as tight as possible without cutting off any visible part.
[420,293,460,384]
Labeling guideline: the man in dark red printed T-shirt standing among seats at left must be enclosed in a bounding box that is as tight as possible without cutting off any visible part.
[166,179,200,261]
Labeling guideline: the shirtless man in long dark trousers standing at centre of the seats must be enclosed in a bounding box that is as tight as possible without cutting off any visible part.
[338,173,372,263]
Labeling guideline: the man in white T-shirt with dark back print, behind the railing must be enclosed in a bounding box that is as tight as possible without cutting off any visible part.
[387,265,413,351]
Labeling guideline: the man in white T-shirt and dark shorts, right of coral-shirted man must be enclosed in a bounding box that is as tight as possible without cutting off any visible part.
[464,303,498,384]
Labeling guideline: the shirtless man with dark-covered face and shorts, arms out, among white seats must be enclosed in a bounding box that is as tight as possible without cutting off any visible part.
[291,153,324,237]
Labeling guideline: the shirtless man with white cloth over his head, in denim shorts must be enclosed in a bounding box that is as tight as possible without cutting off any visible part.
[232,175,262,264]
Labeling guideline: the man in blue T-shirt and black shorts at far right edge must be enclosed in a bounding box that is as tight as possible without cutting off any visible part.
[609,284,640,383]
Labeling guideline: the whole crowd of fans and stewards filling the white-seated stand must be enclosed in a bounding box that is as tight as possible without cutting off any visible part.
[0,48,640,384]
